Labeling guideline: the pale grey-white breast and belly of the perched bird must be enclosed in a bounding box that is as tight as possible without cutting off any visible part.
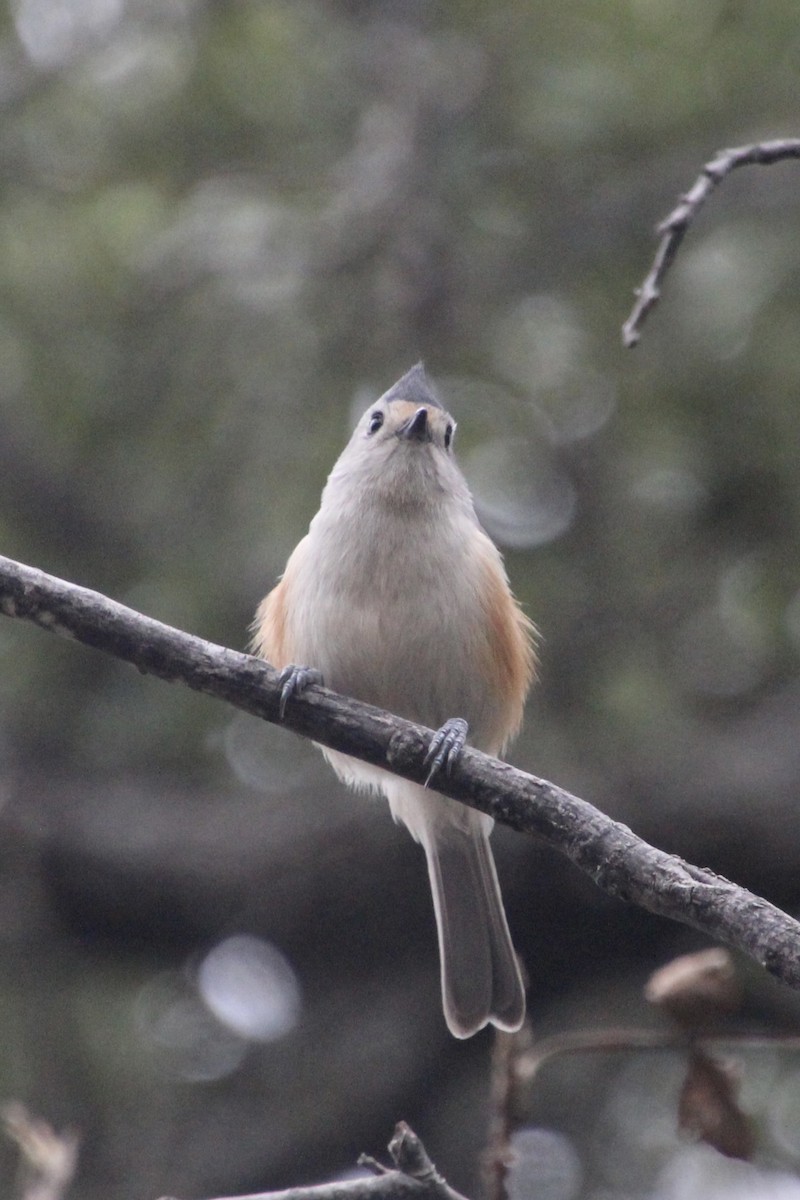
[287,487,501,745]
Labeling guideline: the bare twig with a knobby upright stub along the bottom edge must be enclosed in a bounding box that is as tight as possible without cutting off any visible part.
[163,1121,464,1200]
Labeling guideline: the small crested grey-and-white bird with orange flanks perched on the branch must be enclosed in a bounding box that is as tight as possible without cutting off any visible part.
[252,362,536,1038]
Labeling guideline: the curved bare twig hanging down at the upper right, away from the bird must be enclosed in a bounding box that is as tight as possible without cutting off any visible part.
[622,138,800,348]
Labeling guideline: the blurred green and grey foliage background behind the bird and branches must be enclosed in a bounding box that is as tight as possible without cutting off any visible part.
[0,0,800,1200]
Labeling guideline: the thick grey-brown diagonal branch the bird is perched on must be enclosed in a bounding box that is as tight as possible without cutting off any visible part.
[0,557,800,990]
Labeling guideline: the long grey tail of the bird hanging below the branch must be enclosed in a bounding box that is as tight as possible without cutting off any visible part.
[389,781,525,1038]
